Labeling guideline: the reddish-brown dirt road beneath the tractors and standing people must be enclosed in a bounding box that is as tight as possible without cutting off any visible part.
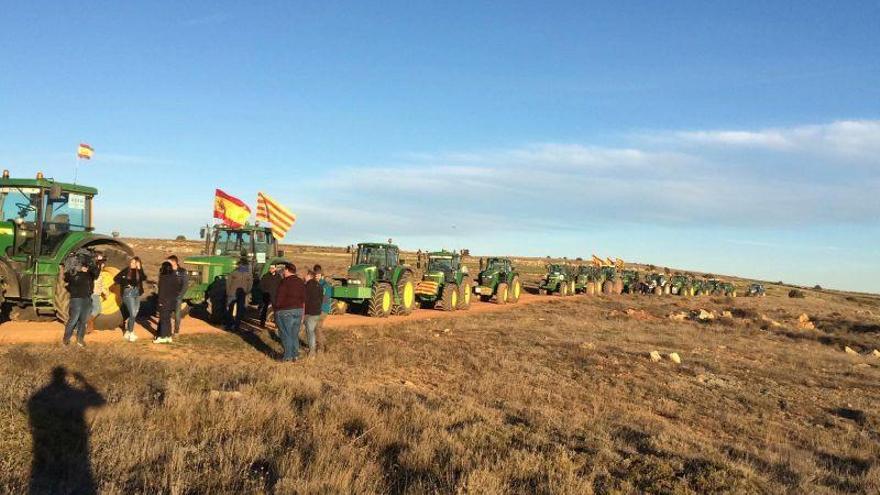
[0,293,548,345]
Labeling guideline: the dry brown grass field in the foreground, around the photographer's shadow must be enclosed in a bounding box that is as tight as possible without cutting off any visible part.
[0,280,880,494]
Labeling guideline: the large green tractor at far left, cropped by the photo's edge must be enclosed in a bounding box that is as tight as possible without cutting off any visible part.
[0,171,134,329]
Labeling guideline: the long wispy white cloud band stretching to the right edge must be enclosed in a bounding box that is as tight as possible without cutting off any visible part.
[294,121,880,235]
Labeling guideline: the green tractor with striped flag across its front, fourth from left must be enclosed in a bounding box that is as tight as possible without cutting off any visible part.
[415,251,473,311]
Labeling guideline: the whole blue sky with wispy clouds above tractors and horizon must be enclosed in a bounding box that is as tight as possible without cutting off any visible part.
[0,1,880,292]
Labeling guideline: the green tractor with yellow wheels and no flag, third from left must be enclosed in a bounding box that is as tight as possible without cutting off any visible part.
[333,242,416,318]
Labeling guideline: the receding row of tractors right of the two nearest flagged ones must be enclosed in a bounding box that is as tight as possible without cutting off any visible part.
[324,242,764,317]
